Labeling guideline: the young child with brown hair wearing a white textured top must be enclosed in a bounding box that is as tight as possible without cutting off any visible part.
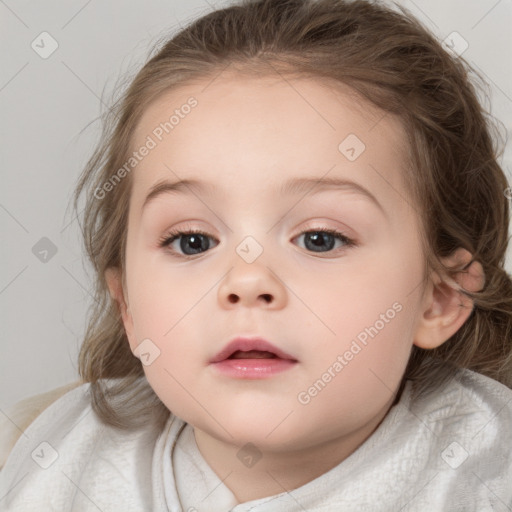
[0,0,512,512]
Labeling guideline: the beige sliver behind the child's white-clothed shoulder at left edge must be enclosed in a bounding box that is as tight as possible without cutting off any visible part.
[0,381,83,469]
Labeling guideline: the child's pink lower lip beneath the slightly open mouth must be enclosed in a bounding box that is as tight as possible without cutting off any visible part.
[212,358,297,379]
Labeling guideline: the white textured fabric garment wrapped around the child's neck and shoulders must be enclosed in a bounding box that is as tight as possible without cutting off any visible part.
[0,370,512,512]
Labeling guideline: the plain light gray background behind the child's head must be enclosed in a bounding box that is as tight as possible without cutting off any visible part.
[0,0,512,412]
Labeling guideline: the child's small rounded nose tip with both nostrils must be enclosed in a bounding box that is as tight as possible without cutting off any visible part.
[219,260,287,309]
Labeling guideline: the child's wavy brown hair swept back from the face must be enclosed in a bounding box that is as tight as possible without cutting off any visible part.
[74,0,512,428]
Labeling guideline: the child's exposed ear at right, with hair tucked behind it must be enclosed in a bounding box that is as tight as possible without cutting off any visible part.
[414,248,485,349]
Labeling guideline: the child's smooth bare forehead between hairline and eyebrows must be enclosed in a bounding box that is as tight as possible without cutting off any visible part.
[132,75,407,210]
